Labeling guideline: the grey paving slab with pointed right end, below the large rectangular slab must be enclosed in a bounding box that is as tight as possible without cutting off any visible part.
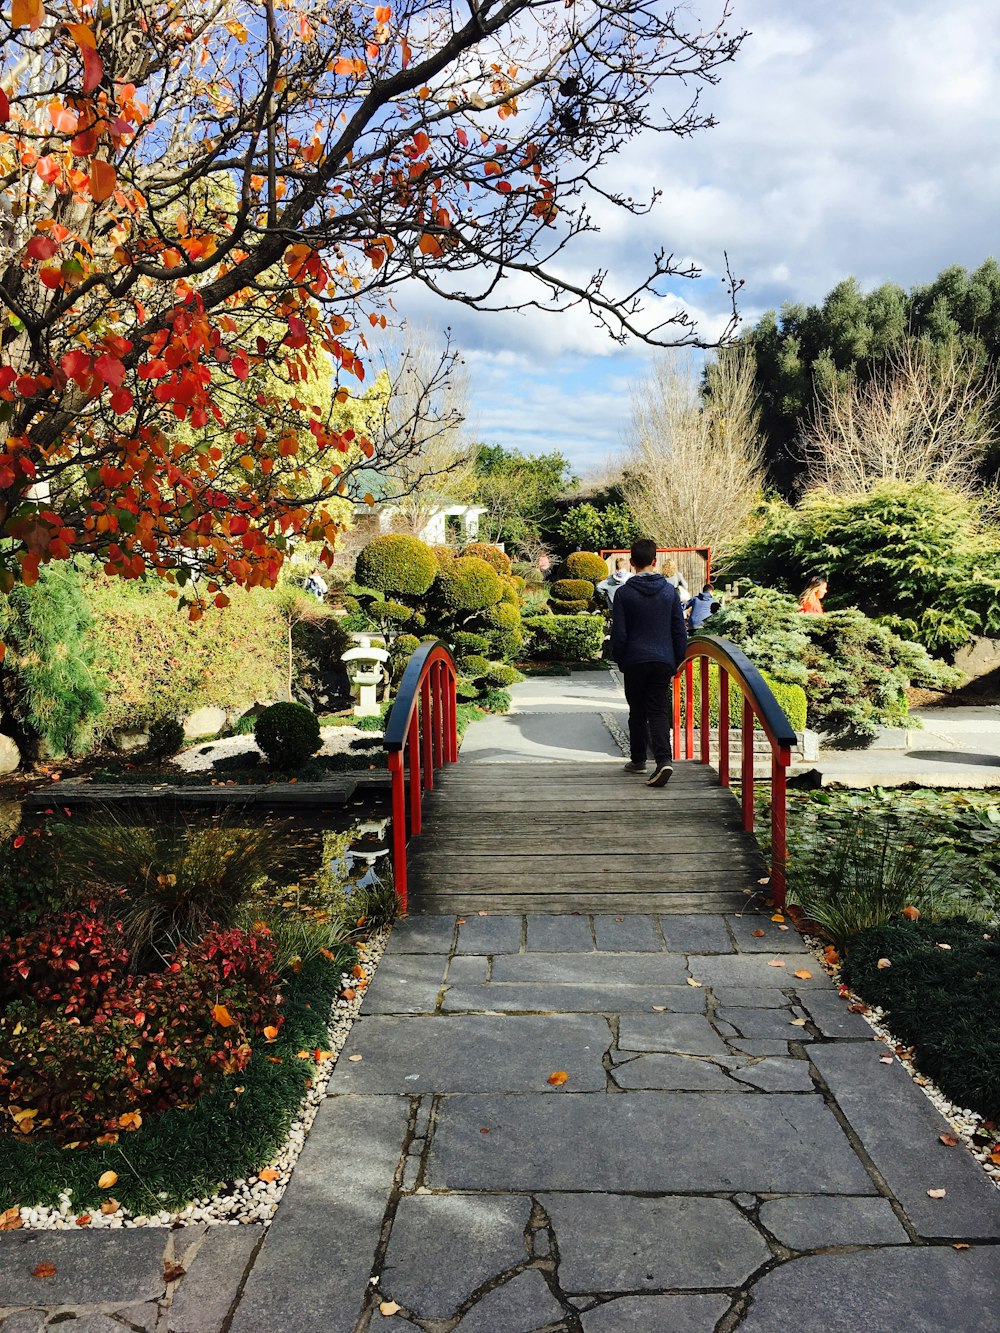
[539,1194,771,1294]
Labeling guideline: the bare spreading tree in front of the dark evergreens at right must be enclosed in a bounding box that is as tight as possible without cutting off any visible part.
[803,339,1000,496]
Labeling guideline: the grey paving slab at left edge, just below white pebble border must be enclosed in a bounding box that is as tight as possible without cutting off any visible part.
[0,1228,169,1306]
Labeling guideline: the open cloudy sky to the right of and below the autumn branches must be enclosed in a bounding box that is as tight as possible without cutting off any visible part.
[400,0,1000,473]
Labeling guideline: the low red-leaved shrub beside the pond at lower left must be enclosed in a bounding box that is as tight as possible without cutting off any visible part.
[0,916,281,1142]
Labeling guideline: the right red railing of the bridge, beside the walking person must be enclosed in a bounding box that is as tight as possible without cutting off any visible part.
[673,635,796,906]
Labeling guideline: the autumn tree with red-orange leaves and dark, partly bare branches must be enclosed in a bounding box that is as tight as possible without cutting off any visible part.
[0,0,743,629]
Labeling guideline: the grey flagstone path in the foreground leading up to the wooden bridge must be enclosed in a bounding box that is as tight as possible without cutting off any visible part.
[0,697,1000,1333]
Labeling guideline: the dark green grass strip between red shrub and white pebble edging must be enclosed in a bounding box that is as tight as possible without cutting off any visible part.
[0,946,356,1214]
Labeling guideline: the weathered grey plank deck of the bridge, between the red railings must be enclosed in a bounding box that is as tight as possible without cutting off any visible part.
[408,761,767,914]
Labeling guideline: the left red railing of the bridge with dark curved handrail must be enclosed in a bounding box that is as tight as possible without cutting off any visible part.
[385,640,459,912]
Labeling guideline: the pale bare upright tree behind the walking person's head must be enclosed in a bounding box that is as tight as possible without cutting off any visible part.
[621,344,764,549]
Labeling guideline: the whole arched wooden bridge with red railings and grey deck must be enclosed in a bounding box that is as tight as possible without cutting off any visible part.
[385,640,795,916]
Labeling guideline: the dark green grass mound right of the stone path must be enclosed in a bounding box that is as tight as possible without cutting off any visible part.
[843,917,1000,1121]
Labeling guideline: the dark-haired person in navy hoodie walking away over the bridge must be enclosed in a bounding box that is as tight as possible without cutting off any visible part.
[611,537,688,786]
